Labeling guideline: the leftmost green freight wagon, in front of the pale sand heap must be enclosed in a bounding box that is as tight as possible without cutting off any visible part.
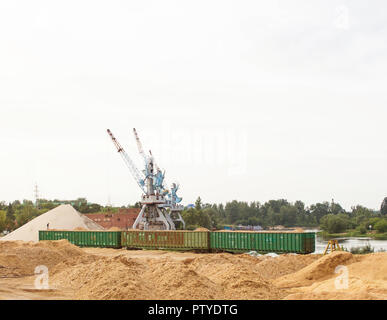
[39,230,122,248]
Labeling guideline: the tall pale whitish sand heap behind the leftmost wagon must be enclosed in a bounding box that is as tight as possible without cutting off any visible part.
[0,204,104,242]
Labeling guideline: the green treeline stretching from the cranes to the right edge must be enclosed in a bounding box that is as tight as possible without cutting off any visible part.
[182,197,387,234]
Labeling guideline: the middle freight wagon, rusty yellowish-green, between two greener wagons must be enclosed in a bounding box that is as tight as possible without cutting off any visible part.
[121,230,210,251]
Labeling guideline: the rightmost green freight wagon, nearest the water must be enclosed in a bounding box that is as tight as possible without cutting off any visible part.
[210,231,315,254]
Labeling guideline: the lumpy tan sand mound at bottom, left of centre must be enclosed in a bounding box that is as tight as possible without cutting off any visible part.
[51,255,221,300]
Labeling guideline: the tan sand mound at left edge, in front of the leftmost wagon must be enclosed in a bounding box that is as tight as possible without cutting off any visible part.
[0,240,86,277]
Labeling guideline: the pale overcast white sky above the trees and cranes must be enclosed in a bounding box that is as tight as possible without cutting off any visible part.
[0,0,387,209]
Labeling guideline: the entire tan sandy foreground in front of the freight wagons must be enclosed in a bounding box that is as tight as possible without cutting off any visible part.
[0,240,387,300]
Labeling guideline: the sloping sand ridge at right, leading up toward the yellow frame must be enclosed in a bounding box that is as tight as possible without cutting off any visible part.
[275,251,353,288]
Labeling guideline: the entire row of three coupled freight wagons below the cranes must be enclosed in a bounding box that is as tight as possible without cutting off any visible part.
[39,230,315,254]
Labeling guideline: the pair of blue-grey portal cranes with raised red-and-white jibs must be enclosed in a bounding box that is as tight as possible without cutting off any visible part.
[107,129,185,230]
